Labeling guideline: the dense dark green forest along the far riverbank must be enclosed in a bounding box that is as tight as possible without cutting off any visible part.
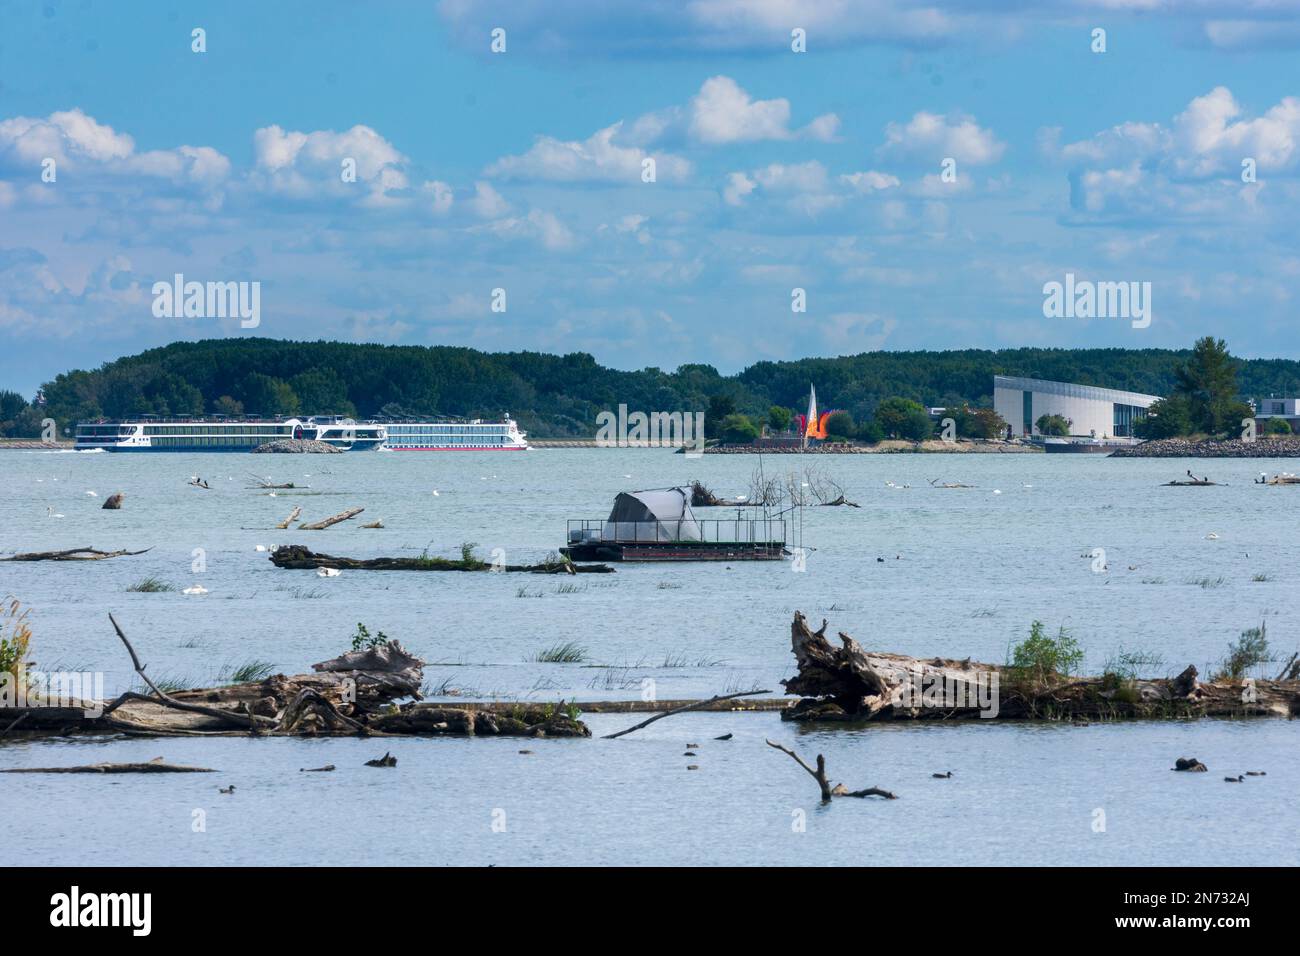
[0,338,1300,438]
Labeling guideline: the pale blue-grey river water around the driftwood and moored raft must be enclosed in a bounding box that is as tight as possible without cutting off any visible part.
[0,449,1300,865]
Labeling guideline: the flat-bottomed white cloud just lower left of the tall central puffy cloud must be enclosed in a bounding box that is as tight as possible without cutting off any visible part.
[485,122,690,185]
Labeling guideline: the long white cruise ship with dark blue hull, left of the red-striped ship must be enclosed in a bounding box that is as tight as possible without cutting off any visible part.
[73,416,387,451]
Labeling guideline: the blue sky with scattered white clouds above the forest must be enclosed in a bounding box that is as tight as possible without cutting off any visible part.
[0,0,1300,395]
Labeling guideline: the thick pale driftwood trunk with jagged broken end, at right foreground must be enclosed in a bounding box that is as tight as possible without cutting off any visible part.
[781,611,1300,722]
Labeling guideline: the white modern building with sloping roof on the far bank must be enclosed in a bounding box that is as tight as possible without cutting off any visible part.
[993,375,1160,438]
